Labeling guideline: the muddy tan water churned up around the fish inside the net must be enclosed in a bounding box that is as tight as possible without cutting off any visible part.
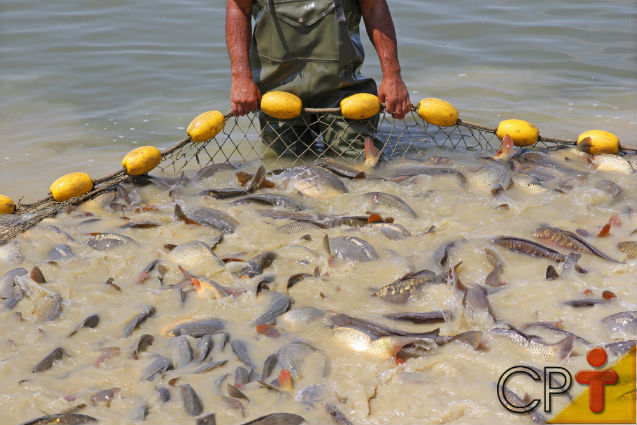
[0,151,637,425]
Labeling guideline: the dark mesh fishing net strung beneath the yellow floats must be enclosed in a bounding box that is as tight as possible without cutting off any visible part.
[0,104,632,245]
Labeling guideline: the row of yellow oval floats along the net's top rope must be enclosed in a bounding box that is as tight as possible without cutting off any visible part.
[0,91,619,214]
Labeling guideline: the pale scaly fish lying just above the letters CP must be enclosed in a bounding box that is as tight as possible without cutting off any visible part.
[488,328,575,362]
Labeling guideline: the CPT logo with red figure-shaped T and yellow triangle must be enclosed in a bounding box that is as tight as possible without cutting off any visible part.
[498,347,635,423]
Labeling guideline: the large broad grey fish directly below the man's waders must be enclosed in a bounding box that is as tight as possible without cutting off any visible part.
[281,166,349,199]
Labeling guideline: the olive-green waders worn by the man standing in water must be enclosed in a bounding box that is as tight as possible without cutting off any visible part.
[250,0,382,157]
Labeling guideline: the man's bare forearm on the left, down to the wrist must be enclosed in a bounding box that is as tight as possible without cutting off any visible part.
[226,0,252,79]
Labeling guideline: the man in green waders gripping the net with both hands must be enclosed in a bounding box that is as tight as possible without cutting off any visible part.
[226,0,411,157]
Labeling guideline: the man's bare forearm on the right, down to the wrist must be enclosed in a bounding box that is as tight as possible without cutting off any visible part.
[359,0,400,77]
